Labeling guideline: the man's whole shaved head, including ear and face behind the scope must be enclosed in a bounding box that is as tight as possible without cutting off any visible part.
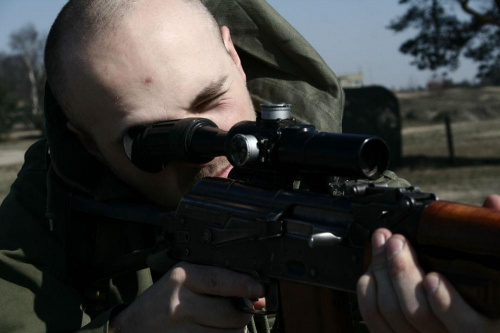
[41,0,255,207]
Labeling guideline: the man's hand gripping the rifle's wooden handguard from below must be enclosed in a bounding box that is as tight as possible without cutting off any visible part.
[358,195,500,333]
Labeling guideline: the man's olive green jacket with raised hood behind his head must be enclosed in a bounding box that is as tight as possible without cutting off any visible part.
[0,0,344,332]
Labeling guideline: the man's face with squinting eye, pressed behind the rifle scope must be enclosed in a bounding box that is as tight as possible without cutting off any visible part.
[68,0,255,207]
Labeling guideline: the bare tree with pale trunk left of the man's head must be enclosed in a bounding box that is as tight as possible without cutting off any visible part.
[9,24,45,129]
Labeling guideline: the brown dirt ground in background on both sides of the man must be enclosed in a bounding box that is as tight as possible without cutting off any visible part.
[0,87,500,204]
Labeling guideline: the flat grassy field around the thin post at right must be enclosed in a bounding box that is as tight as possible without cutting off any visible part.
[396,119,500,204]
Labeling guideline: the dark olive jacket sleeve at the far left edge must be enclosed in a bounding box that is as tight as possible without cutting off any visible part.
[0,141,121,332]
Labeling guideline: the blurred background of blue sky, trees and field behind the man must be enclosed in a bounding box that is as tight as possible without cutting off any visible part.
[0,0,500,204]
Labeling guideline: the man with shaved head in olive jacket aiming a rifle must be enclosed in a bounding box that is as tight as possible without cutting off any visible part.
[0,0,500,332]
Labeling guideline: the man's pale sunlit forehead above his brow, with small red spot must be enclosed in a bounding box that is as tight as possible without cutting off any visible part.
[71,1,229,133]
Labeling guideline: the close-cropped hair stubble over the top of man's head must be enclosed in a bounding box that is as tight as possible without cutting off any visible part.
[44,0,223,131]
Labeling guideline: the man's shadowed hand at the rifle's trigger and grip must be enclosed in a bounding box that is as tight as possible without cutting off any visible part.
[110,263,264,332]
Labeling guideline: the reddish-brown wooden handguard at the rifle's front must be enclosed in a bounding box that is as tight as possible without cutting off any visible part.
[417,201,500,318]
